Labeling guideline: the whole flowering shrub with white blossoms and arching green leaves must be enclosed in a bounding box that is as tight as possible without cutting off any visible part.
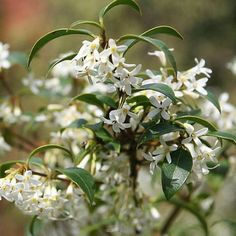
[0,0,236,235]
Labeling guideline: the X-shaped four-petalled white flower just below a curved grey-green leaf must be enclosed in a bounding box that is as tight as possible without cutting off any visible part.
[148,96,171,120]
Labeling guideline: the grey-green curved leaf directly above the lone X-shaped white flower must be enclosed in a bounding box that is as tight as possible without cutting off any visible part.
[134,83,176,102]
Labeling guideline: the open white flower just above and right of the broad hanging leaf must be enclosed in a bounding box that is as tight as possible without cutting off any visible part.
[182,123,208,145]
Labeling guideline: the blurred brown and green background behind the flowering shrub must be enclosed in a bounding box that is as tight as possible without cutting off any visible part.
[0,0,236,236]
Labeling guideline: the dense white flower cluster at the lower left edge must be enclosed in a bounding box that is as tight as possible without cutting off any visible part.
[0,169,80,220]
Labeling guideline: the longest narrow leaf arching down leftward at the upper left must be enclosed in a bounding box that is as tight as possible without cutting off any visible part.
[27,28,94,67]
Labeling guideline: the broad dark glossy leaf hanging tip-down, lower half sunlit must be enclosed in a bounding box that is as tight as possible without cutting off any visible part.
[161,148,193,200]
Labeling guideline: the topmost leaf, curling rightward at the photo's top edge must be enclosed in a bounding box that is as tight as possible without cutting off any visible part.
[99,0,142,21]
